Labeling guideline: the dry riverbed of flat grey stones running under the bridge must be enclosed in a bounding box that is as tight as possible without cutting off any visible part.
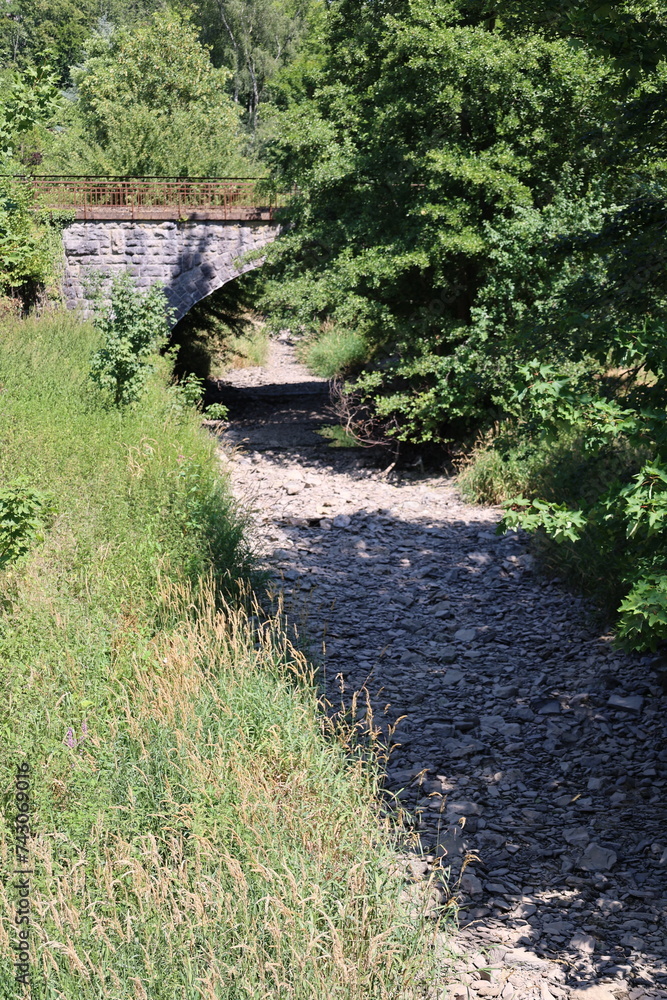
[211,343,667,1000]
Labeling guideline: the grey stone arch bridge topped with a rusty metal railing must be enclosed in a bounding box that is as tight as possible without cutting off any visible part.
[30,177,287,321]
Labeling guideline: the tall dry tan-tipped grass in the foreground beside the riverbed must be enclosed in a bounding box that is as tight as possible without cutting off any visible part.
[0,582,448,1000]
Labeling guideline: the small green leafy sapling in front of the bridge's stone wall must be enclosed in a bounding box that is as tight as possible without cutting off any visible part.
[90,272,174,409]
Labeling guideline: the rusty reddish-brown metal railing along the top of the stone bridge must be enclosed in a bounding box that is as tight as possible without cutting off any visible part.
[7,174,290,218]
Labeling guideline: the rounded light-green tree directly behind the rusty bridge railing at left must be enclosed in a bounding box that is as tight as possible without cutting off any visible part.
[45,10,253,177]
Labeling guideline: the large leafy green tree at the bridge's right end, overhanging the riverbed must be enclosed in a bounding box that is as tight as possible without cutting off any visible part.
[266,0,615,440]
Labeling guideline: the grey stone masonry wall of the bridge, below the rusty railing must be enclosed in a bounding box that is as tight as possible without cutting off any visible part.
[63,220,278,320]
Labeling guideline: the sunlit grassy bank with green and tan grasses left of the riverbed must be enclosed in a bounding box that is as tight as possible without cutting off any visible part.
[0,316,438,1000]
